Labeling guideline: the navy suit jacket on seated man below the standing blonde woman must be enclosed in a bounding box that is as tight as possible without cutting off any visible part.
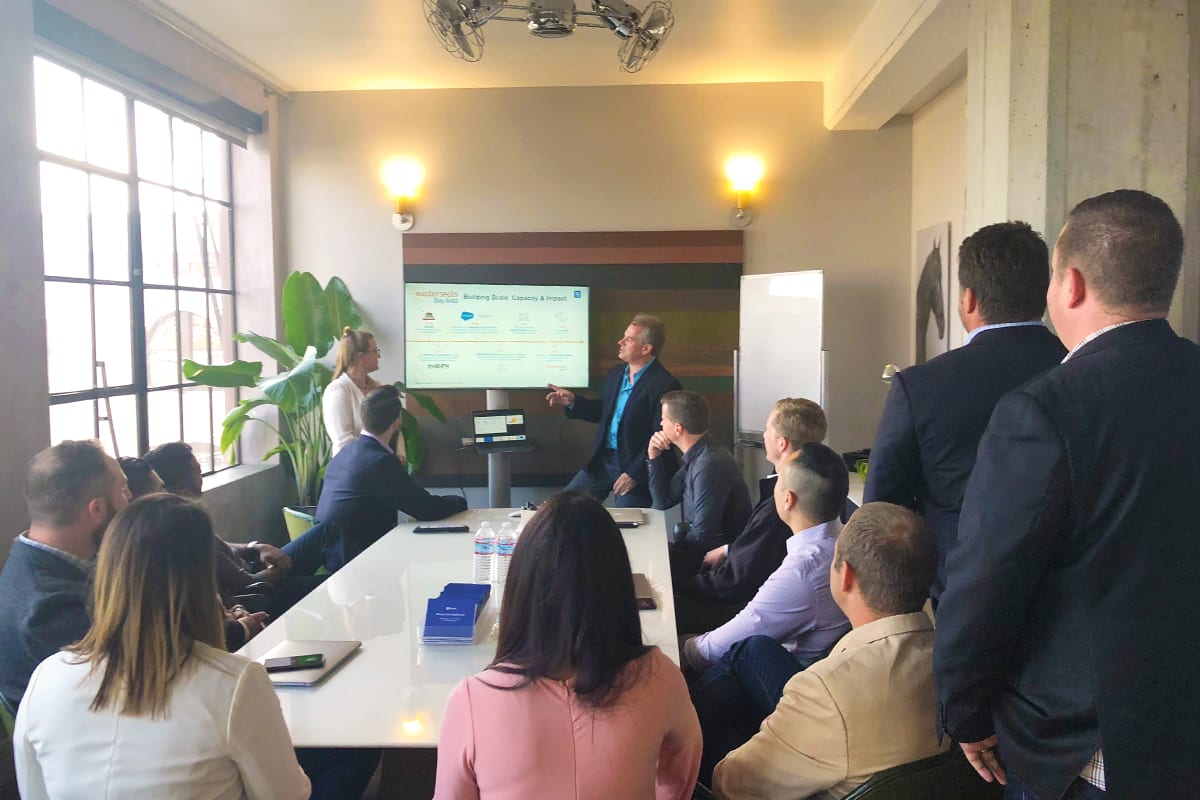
[316,435,467,566]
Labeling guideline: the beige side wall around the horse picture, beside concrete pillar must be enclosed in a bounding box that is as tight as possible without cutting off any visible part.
[912,77,971,357]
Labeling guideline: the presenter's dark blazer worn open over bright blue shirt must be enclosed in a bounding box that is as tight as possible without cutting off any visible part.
[566,359,683,497]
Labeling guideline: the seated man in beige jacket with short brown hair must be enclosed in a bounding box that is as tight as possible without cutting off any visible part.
[713,503,948,800]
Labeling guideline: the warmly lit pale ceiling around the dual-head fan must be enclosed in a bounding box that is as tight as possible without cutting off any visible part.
[131,0,888,91]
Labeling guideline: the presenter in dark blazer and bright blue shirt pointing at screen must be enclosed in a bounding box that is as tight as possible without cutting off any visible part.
[546,314,682,509]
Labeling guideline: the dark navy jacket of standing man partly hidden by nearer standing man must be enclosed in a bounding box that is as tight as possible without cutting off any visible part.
[863,325,1067,600]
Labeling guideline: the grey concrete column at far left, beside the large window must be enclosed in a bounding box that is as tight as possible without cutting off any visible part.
[0,0,50,561]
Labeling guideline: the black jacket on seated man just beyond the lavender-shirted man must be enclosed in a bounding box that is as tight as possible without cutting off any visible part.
[678,475,792,604]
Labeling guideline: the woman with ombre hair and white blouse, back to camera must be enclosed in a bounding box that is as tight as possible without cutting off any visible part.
[13,494,310,800]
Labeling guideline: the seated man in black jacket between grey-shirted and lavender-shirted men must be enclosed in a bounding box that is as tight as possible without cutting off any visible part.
[673,397,828,634]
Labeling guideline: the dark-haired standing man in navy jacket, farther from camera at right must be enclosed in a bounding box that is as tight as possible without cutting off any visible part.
[863,222,1067,604]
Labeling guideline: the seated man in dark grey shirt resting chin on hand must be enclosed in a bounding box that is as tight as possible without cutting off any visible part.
[647,391,750,582]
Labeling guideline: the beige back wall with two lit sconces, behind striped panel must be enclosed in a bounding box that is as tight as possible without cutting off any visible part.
[283,84,912,450]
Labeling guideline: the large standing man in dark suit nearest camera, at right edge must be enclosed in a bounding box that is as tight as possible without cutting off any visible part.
[934,190,1200,800]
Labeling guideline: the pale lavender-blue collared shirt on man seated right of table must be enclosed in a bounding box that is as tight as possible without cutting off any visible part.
[695,519,850,664]
